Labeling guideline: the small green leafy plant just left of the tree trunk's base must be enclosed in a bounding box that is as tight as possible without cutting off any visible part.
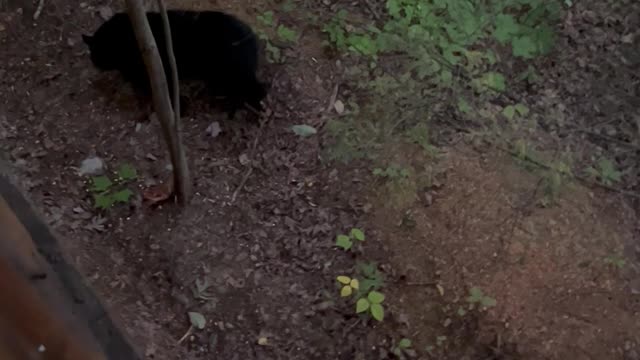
[89,164,138,210]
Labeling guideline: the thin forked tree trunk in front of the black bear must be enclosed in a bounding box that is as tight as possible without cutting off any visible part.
[126,0,191,205]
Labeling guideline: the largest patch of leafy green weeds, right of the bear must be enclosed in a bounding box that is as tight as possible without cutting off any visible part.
[323,0,562,161]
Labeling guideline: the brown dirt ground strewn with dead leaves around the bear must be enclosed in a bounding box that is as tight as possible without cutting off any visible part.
[0,0,640,360]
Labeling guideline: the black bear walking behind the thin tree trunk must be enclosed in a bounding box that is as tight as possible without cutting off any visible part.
[82,10,266,118]
